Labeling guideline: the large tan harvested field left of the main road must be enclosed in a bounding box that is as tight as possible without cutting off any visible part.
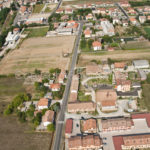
[0,36,75,74]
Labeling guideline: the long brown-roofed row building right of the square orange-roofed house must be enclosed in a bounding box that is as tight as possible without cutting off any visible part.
[100,117,133,132]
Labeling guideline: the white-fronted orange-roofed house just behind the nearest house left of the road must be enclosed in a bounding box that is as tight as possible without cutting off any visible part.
[37,98,50,110]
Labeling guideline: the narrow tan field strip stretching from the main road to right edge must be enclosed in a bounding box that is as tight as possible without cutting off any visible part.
[78,49,150,66]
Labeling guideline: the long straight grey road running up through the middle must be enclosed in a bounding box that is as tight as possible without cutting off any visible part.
[52,22,83,150]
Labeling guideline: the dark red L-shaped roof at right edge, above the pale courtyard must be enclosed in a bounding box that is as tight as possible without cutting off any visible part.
[131,113,150,127]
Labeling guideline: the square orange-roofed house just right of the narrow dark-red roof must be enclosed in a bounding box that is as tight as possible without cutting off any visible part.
[81,118,97,133]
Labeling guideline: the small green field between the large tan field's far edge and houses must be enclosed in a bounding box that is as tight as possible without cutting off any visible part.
[24,27,49,38]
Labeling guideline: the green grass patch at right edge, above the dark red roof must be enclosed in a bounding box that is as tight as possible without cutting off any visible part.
[139,84,150,111]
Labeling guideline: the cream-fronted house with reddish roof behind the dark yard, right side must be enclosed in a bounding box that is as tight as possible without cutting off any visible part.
[116,79,131,92]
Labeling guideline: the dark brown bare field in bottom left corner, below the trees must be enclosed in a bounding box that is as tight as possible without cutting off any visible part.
[0,116,52,150]
